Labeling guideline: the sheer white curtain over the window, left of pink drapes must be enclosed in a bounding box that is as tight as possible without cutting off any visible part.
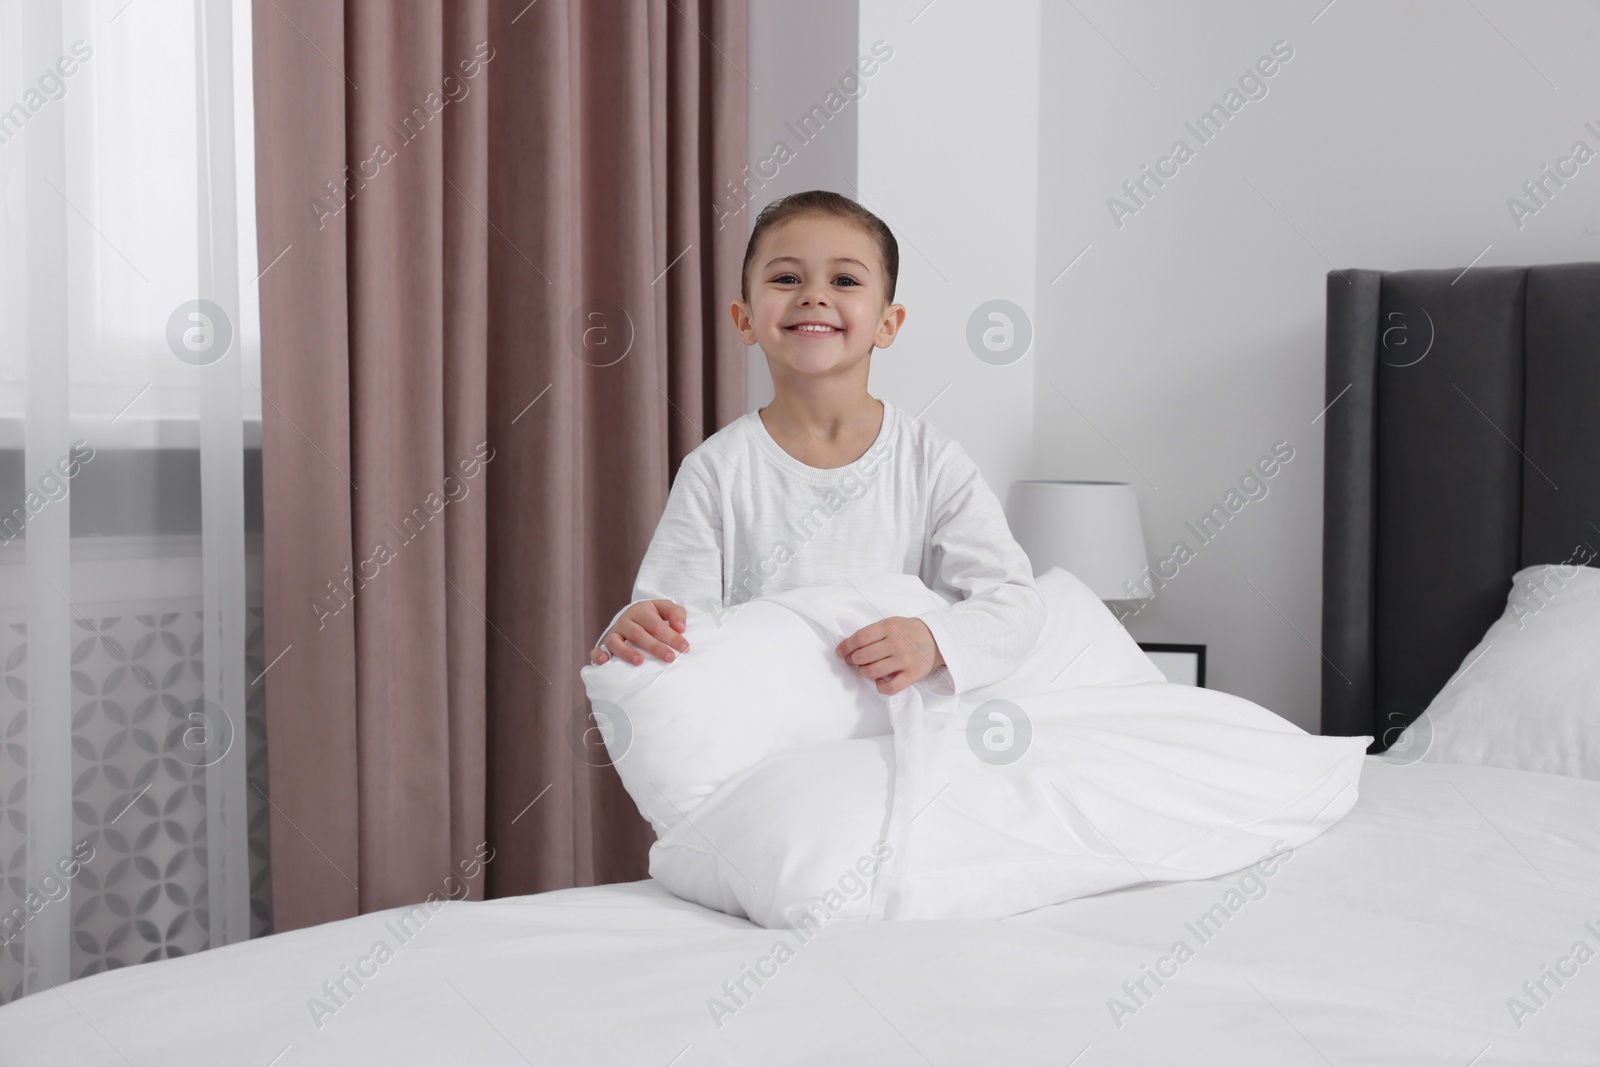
[0,0,270,1001]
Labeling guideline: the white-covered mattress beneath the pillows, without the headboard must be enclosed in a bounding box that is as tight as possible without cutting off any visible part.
[0,758,1600,1067]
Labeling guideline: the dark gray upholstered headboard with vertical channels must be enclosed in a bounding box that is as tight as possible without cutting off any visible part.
[1322,262,1600,752]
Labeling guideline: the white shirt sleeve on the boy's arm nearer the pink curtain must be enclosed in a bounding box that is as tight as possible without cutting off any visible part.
[595,453,723,646]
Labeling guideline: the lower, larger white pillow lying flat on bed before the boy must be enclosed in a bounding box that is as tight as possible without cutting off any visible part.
[650,569,1371,928]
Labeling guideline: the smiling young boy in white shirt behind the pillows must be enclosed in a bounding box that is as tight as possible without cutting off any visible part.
[589,190,1045,696]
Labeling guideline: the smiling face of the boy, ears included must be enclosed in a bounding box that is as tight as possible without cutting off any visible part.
[730,213,906,381]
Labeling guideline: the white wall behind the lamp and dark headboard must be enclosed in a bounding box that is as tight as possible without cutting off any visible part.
[1034,0,1600,729]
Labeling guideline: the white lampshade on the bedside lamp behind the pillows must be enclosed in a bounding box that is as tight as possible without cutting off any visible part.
[1006,482,1150,600]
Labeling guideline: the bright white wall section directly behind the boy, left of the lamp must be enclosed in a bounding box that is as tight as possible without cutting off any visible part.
[846,0,1040,501]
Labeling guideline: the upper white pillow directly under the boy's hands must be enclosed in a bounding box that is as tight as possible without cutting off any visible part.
[579,574,949,837]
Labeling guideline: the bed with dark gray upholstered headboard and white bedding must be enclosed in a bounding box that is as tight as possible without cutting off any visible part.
[9,267,1600,1067]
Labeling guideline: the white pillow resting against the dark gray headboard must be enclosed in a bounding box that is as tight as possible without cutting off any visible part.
[1390,563,1600,779]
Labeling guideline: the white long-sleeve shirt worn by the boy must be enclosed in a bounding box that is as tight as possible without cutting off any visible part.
[595,400,1045,693]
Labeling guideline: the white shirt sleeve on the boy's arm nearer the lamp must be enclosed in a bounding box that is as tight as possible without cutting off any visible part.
[917,442,1045,694]
